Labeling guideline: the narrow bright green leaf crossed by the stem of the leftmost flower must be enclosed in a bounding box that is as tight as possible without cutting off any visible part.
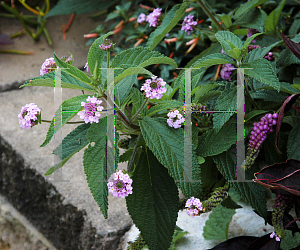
[40,95,89,147]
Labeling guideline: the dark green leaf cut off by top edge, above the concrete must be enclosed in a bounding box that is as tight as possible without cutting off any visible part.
[45,0,117,18]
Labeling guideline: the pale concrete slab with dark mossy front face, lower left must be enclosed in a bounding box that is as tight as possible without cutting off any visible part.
[0,87,132,249]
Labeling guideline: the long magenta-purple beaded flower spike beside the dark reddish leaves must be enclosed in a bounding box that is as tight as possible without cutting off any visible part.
[245,113,278,169]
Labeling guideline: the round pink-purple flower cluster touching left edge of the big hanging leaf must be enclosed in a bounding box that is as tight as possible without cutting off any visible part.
[107,170,132,198]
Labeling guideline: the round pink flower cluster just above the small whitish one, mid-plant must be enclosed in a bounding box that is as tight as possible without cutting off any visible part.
[141,76,167,99]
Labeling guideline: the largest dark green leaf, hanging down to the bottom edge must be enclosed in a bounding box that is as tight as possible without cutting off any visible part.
[126,149,179,250]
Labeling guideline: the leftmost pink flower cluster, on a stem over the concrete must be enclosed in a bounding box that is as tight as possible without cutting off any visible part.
[18,103,41,129]
